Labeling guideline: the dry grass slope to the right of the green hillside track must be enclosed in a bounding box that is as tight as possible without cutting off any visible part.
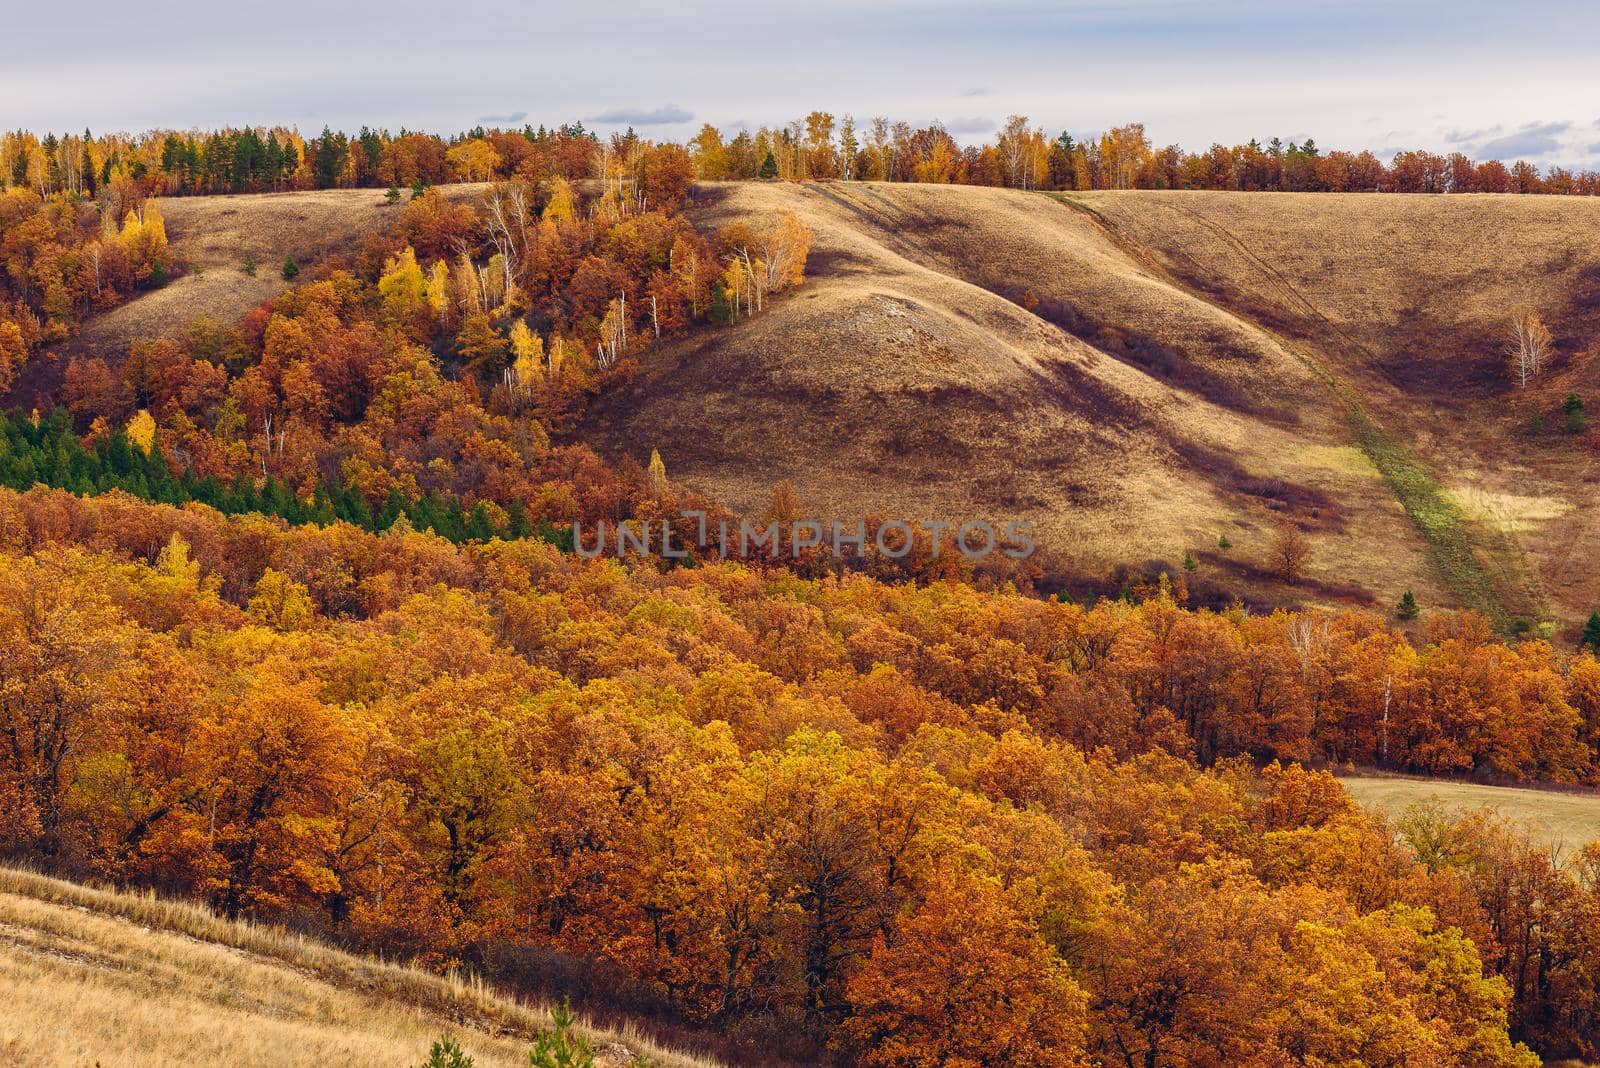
[1077,192,1600,638]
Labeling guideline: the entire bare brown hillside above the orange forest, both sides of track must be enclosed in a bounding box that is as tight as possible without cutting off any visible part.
[592,182,1600,624]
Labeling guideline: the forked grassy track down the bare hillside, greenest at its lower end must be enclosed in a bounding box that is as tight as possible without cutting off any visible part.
[1045,193,1547,633]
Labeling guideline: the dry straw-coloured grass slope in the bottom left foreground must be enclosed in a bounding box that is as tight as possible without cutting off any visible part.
[0,868,712,1068]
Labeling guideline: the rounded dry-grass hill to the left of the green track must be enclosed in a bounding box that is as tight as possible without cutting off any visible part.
[589,182,1448,604]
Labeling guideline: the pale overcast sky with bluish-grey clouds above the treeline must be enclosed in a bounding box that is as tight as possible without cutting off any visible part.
[9,0,1600,166]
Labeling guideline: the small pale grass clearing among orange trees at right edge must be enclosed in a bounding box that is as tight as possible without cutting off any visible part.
[1339,775,1600,857]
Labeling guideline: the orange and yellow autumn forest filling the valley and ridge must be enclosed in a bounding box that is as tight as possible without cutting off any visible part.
[0,112,1600,1068]
